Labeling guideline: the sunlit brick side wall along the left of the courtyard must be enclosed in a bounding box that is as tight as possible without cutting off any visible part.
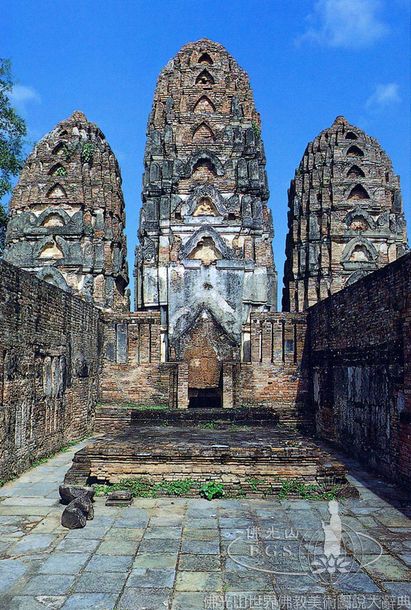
[0,261,101,480]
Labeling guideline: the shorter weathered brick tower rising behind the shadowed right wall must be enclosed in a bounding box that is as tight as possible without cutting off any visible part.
[283,116,407,312]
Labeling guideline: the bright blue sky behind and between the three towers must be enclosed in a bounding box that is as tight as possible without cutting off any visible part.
[0,0,411,304]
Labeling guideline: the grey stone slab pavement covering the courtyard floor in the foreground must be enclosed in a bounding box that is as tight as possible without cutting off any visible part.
[0,436,411,610]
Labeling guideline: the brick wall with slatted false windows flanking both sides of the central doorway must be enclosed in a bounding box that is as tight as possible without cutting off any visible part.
[101,311,308,416]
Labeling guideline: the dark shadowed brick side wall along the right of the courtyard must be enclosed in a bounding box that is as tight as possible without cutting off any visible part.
[308,253,411,481]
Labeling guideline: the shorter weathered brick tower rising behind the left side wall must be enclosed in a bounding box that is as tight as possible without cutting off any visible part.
[4,112,129,311]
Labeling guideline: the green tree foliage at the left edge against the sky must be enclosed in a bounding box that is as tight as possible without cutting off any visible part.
[0,59,27,252]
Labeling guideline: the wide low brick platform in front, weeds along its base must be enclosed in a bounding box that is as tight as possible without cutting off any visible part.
[65,426,346,492]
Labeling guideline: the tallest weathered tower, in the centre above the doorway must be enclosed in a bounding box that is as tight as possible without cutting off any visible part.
[135,39,276,400]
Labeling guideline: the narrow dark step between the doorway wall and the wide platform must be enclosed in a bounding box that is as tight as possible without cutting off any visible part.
[94,404,313,433]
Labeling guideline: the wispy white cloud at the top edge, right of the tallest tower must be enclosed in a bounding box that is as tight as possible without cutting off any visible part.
[297,0,388,49]
